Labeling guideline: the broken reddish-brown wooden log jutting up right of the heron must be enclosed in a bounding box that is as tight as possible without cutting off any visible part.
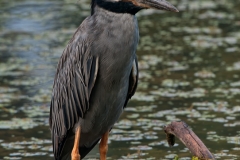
[164,121,215,159]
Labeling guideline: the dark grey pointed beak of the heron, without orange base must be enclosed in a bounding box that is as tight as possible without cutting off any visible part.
[141,0,179,12]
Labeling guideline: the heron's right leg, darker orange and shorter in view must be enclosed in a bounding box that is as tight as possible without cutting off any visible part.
[99,131,109,160]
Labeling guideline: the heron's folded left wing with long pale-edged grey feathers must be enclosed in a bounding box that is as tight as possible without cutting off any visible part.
[49,32,98,157]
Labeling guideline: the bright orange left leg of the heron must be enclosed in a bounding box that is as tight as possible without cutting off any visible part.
[71,126,81,160]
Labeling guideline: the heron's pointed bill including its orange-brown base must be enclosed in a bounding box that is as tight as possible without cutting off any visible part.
[128,0,179,12]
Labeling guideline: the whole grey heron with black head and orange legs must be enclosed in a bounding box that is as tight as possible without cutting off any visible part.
[49,0,178,160]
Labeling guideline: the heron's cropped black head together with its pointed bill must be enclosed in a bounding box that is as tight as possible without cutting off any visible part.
[92,0,178,14]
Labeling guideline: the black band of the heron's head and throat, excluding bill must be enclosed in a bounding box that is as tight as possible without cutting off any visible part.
[91,0,143,15]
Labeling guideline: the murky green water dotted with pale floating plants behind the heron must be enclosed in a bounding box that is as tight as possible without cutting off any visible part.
[0,0,240,160]
